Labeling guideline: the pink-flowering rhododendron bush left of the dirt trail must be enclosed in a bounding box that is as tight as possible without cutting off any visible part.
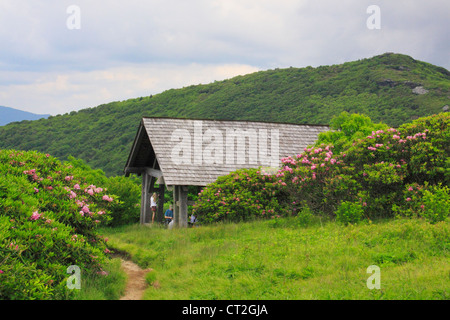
[0,150,118,299]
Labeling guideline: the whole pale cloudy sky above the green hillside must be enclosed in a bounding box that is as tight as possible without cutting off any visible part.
[0,0,450,115]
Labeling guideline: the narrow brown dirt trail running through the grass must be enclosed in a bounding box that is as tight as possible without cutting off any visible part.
[120,259,152,300]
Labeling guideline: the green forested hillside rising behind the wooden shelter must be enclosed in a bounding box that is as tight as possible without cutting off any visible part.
[0,53,450,175]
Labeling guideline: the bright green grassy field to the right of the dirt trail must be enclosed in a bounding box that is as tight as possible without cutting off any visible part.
[102,218,450,300]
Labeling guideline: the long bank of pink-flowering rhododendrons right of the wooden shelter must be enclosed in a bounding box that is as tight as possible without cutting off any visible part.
[194,113,450,222]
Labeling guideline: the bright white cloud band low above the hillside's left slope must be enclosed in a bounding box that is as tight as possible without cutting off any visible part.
[0,63,258,115]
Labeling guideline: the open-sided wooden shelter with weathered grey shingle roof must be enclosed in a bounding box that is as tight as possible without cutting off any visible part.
[124,118,329,227]
